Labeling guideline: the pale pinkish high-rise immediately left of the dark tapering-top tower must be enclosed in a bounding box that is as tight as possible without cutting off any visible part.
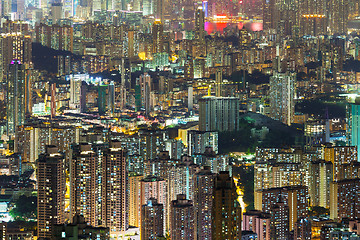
[193,166,215,240]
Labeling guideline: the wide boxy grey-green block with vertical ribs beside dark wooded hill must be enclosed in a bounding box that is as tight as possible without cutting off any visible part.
[199,97,240,132]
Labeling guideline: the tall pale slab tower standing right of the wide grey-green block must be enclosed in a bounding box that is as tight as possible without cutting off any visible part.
[269,72,296,125]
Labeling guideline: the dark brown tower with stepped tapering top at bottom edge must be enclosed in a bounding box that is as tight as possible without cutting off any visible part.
[211,172,241,240]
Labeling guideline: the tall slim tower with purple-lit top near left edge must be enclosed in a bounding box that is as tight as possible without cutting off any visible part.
[6,60,26,136]
